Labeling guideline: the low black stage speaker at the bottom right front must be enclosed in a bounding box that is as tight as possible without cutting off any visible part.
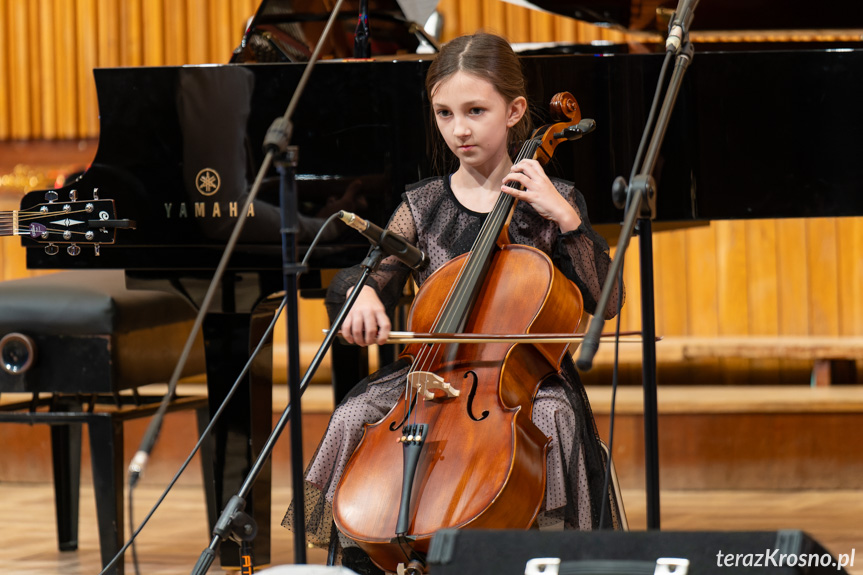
[427,529,855,575]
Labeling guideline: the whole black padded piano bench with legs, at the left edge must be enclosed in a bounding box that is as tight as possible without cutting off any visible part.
[0,270,213,575]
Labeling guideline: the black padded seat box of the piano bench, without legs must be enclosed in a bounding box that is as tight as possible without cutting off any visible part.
[0,270,206,394]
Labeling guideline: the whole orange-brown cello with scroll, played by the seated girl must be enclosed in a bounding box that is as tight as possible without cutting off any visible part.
[333,92,583,573]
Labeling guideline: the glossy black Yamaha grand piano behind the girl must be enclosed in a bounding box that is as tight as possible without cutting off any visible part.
[15,0,863,565]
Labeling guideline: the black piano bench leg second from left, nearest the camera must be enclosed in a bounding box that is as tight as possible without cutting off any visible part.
[88,414,125,575]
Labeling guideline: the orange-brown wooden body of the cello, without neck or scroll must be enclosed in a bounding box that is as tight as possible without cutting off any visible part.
[333,245,583,571]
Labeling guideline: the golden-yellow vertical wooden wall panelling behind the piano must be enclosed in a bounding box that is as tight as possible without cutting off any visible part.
[0,0,863,384]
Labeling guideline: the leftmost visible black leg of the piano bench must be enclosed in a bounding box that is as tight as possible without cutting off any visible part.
[51,423,81,551]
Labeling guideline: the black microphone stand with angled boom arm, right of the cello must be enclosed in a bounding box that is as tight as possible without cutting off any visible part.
[576,29,694,529]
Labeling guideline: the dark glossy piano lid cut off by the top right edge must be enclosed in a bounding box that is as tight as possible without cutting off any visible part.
[506,0,863,32]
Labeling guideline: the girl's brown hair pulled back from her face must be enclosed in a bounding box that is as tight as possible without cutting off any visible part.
[426,32,531,170]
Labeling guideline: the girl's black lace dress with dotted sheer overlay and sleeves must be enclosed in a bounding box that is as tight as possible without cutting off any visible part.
[282,177,619,564]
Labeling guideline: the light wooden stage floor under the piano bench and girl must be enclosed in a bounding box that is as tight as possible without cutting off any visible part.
[0,482,863,575]
